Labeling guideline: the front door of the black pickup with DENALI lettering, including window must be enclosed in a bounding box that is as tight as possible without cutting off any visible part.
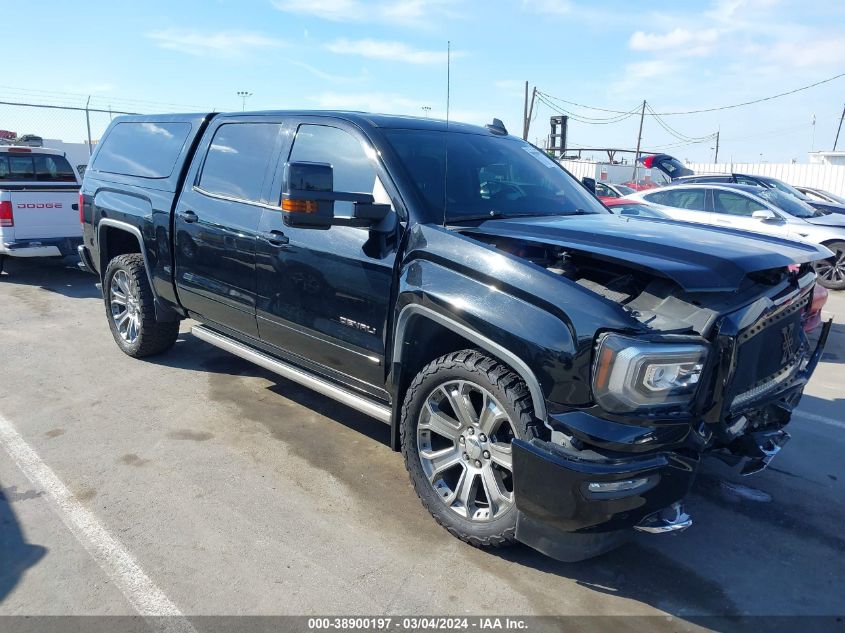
[257,124,396,396]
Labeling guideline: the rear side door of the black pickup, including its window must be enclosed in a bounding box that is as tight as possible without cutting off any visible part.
[174,117,282,337]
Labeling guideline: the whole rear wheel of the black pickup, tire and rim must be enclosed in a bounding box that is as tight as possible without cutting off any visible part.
[103,253,179,358]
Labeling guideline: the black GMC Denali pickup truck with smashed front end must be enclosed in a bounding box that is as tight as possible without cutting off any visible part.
[80,112,830,560]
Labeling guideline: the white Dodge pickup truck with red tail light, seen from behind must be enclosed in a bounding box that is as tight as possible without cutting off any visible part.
[0,146,82,272]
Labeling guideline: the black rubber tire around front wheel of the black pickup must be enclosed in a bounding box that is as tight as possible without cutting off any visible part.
[400,350,541,547]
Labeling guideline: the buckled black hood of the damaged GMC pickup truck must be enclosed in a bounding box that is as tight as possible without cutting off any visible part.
[462,213,830,292]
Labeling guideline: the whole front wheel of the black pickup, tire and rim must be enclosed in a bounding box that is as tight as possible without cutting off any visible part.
[400,350,539,547]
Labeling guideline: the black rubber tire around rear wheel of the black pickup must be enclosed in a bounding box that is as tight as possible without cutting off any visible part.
[103,253,179,358]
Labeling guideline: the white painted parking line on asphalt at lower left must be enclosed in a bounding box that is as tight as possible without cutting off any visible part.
[0,415,196,633]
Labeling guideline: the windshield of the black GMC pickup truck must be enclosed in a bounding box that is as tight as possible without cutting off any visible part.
[385,129,607,222]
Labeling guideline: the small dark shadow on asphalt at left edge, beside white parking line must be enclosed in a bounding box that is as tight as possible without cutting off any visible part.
[0,478,47,604]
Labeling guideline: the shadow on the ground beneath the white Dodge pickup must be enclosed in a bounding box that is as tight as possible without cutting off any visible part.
[0,257,102,299]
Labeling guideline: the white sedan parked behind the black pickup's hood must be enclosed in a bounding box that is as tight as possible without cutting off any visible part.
[627,184,845,290]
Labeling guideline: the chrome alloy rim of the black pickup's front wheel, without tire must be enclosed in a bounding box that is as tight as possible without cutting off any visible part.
[417,380,516,521]
